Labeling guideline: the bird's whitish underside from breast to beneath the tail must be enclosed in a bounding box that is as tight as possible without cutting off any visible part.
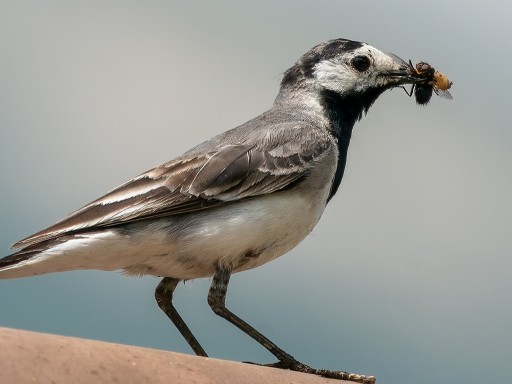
[0,190,327,279]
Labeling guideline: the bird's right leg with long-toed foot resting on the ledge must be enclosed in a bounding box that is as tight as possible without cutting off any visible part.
[208,266,375,384]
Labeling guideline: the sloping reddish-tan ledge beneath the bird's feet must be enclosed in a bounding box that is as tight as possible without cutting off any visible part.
[0,328,349,384]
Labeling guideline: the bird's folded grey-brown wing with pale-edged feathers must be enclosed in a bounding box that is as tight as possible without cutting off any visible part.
[13,127,333,247]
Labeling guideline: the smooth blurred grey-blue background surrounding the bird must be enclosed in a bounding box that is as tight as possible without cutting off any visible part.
[0,0,512,384]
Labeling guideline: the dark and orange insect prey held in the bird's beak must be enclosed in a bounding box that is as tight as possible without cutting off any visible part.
[409,60,453,105]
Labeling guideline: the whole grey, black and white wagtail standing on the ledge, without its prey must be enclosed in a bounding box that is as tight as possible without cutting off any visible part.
[0,39,440,383]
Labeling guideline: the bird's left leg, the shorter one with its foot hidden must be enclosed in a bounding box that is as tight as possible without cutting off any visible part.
[155,277,208,357]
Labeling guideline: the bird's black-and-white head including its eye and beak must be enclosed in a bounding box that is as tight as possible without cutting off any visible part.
[277,39,420,120]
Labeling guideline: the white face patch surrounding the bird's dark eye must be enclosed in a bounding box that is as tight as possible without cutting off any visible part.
[314,43,397,95]
